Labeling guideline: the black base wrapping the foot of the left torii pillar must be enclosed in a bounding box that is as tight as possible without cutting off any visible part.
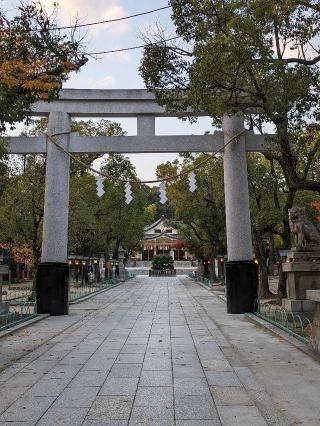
[37,263,69,316]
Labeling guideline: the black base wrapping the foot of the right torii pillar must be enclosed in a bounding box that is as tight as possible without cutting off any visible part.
[225,261,258,314]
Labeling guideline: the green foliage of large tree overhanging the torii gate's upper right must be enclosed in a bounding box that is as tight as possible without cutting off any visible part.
[140,0,320,196]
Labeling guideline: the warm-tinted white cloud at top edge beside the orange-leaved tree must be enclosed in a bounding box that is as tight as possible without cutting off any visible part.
[41,0,131,37]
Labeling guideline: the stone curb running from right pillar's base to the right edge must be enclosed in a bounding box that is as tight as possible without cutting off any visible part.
[244,313,320,362]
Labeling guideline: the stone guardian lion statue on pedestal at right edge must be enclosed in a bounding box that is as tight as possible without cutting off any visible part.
[289,207,320,248]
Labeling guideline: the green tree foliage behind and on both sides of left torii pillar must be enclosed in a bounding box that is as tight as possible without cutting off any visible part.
[0,120,151,260]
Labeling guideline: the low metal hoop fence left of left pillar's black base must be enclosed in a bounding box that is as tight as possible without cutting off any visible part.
[0,301,37,331]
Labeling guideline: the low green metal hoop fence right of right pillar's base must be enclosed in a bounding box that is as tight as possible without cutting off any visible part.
[254,299,312,343]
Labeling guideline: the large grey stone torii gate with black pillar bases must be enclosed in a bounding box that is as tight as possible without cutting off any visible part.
[8,89,272,315]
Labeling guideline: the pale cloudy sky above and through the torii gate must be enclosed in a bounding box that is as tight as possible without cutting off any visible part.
[0,0,212,180]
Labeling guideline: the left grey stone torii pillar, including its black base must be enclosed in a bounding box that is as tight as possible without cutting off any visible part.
[37,112,70,315]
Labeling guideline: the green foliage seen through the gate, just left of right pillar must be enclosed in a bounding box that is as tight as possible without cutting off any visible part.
[158,154,226,258]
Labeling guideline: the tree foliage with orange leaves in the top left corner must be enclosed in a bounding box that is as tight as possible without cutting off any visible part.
[0,2,87,131]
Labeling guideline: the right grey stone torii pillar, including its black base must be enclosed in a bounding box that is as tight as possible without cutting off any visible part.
[222,114,258,314]
